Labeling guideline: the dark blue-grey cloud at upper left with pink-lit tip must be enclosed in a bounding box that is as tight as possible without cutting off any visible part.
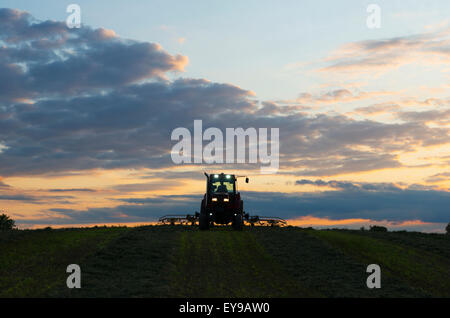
[0,9,187,101]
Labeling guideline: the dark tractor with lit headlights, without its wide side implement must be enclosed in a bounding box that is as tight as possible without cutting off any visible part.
[198,173,248,230]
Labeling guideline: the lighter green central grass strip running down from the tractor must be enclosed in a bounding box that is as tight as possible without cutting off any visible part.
[171,227,317,297]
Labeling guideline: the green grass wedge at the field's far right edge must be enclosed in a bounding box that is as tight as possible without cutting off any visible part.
[311,231,450,297]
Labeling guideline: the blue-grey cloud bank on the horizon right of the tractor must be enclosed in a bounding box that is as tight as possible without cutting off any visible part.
[245,190,450,223]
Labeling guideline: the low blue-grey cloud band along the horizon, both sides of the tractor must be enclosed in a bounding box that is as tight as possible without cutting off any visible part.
[18,186,450,224]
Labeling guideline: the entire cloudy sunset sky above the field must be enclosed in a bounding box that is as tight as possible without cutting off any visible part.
[0,0,450,232]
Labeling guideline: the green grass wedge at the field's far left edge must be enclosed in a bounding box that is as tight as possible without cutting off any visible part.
[0,227,127,297]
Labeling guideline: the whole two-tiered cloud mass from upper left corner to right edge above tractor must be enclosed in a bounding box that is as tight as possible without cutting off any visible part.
[0,9,450,176]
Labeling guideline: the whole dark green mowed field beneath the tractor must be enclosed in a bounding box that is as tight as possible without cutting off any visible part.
[0,226,450,298]
